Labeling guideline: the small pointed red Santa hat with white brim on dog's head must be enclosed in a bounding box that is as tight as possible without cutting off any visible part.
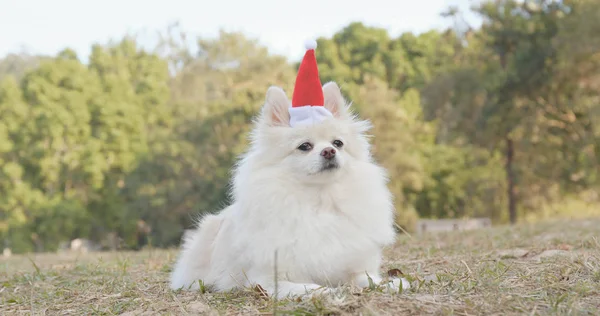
[289,40,333,127]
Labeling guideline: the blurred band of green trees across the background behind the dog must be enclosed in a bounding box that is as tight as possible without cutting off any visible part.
[0,0,600,252]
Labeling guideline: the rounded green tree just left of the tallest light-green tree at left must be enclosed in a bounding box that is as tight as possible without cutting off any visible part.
[15,50,103,248]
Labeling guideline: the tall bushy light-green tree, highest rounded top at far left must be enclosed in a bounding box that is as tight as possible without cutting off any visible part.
[89,37,172,247]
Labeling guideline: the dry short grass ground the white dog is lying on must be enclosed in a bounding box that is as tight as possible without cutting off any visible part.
[0,219,600,315]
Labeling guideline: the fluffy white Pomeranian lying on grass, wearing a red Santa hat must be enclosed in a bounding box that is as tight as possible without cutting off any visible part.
[171,43,410,298]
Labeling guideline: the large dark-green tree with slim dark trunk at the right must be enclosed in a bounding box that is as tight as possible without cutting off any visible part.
[425,0,591,223]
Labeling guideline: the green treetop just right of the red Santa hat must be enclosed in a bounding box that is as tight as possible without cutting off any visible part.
[318,22,461,93]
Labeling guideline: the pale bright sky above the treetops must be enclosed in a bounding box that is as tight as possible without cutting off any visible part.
[0,0,479,60]
